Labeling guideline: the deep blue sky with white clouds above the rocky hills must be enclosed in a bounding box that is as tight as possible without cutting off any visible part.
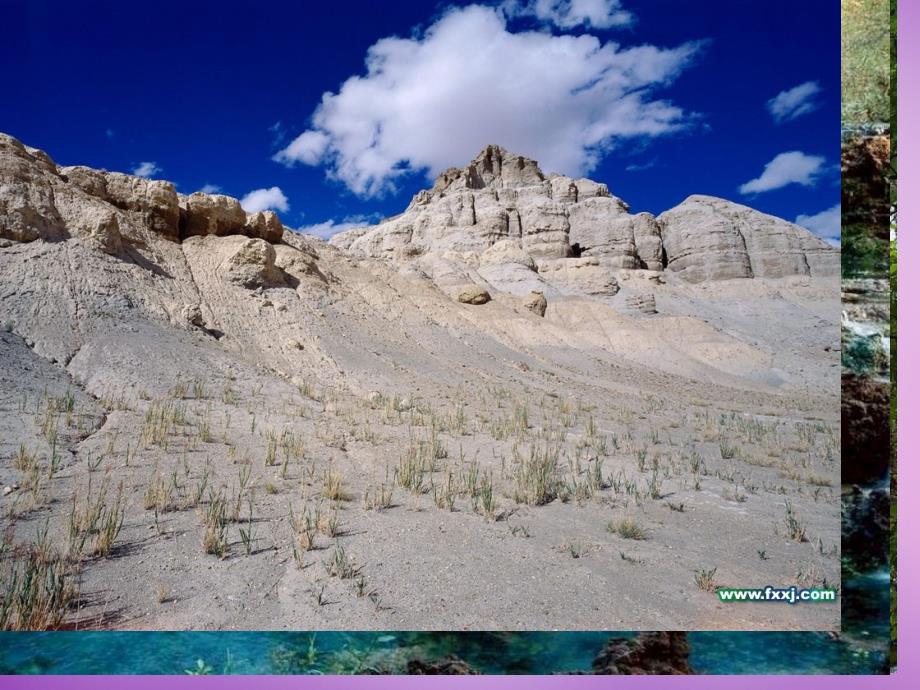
[0,0,840,242]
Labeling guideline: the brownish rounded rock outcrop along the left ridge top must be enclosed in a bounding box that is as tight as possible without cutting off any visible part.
[0,134,284,254]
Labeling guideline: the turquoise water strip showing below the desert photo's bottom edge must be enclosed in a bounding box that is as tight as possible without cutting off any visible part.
[0,573,889,674]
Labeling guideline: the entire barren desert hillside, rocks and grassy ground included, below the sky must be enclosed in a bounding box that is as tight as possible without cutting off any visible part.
[0,137,840,630]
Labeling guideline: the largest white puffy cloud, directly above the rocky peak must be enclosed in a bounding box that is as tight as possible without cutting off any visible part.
[275,5,702,196]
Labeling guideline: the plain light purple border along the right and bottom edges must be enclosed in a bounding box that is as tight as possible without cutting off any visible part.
[2,2,908,690]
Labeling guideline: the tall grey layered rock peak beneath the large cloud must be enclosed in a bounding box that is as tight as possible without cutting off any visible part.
[331,145,839,297]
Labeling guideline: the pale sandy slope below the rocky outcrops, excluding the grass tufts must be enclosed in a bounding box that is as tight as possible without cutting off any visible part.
[0,231,839,629]
